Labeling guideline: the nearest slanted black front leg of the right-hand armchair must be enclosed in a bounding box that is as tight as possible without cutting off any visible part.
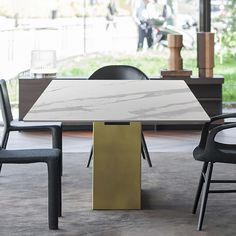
[197,162,213,231]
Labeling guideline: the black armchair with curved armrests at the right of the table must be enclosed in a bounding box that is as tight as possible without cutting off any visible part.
[192,113,236,230]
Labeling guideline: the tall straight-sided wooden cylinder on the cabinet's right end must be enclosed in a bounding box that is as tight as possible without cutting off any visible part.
[197,32,214,78]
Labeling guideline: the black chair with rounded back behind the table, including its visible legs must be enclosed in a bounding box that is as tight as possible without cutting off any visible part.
[87,65,152,167]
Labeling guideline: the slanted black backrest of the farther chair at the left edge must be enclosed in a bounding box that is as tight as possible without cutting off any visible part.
[0,79,13,127]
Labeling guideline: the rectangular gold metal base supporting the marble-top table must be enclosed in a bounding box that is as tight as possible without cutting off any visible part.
[93,122,141,209]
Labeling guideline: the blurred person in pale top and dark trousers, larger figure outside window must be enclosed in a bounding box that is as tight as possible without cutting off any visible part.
[133,0,153,51]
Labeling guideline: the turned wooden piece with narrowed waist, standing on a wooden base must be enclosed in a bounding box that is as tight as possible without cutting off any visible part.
[167,34,183,71]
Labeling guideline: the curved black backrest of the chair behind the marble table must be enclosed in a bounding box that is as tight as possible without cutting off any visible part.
[88,65,149,80]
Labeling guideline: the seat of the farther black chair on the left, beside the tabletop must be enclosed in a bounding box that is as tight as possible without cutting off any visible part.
[10,120,62,130]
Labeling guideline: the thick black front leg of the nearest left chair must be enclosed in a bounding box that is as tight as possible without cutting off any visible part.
[47,159,60,229]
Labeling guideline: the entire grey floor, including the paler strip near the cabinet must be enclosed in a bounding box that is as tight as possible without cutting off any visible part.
[0,128,236,236]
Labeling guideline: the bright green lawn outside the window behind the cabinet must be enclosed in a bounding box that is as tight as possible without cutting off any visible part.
[59,51,236,102]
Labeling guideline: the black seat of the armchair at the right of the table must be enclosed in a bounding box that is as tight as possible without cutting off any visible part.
[193,143,236,164]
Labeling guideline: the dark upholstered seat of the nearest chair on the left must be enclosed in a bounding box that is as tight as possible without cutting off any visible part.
[0,149,60,163]
